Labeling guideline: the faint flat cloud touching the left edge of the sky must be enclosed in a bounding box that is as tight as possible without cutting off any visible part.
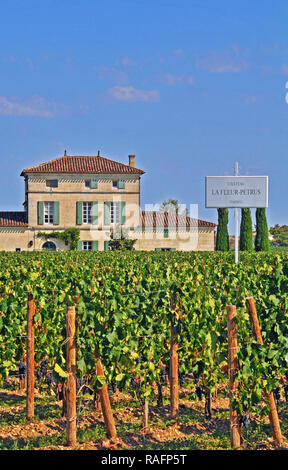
[0,95,67,117]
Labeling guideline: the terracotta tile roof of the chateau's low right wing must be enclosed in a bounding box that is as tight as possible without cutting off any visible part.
[141,211,217,228]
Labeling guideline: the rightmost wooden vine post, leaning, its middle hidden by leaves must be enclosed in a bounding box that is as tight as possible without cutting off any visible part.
[246,297,283,446]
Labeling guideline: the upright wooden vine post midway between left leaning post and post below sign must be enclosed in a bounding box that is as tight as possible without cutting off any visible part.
[170,325,179,418]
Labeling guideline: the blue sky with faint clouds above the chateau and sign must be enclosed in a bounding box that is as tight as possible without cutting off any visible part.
[0,0,288,233]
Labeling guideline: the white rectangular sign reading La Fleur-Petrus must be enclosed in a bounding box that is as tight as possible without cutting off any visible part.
[205,176,268,208]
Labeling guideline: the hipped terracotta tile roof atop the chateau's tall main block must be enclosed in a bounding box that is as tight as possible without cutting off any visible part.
[21,155,145,176]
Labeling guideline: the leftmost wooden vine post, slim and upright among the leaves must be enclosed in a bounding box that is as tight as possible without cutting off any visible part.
[26,292,35,419]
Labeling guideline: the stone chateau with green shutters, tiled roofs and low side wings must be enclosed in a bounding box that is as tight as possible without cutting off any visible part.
[0,151,216,251]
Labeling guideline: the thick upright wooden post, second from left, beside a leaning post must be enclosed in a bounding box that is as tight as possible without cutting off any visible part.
[66,306,77,447]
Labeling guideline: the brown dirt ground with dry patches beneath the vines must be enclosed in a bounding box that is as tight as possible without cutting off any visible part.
[0,389,286,450]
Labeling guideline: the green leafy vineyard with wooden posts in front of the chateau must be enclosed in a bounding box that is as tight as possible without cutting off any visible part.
[0,252,288,449]
